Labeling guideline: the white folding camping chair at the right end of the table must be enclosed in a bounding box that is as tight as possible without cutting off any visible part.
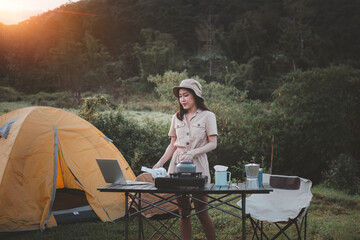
[240,174,312,239]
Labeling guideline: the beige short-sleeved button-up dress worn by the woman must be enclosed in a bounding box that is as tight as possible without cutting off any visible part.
[168,109,217,182]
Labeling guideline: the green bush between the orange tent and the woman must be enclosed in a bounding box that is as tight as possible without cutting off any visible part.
[79,97,170,174]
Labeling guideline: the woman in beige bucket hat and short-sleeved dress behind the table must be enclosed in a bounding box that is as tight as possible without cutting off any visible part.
[153,79,217,239]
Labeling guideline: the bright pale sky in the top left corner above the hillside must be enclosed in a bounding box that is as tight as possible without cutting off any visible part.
[0,0,79,25]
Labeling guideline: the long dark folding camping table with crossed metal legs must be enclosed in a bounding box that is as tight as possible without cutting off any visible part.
[98,183,272,239]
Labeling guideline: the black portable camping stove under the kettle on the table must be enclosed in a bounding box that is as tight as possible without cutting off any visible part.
[155,172,208,189]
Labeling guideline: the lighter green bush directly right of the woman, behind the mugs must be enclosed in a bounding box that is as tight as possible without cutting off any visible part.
[204,82,271,179]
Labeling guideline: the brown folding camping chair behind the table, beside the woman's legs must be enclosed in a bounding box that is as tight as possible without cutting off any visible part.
[130,173,181,240]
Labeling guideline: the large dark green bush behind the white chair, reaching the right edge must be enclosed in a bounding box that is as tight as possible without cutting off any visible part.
[272,66,360,183]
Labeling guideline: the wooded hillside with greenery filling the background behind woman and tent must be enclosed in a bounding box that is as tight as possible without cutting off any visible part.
[0,0,360,193]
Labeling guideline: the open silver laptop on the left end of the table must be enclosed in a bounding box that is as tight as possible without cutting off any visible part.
[96,158,151,185]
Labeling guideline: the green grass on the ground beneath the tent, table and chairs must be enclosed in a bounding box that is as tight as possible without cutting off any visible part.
[0,186,360,240]
